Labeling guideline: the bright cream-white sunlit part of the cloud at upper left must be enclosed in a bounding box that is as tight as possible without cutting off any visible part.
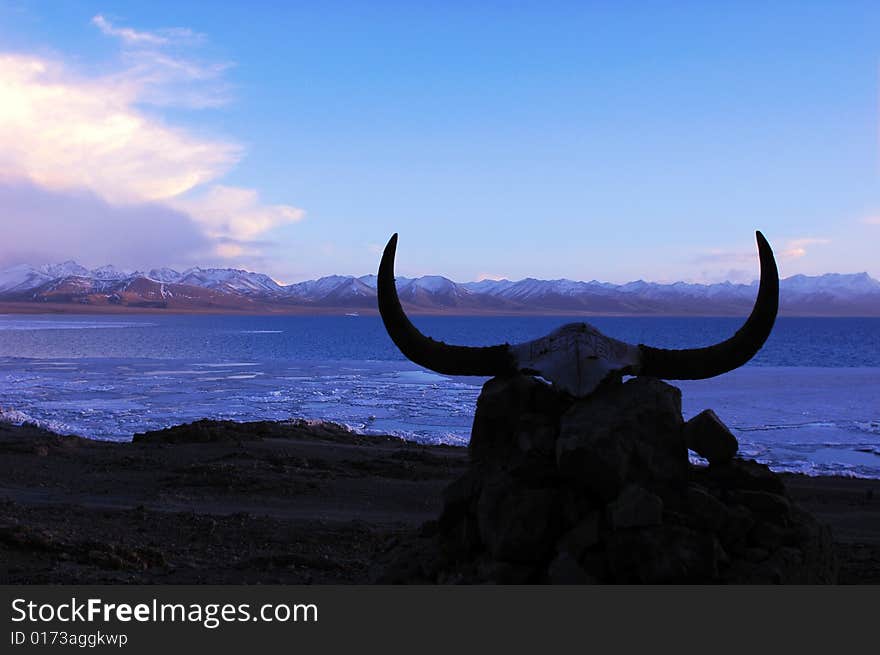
[0,55,241,203]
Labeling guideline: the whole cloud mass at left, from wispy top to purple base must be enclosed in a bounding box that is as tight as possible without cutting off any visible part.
[0,15,304,266]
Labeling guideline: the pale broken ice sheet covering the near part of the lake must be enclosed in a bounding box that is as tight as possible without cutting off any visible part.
[0,358,880,478]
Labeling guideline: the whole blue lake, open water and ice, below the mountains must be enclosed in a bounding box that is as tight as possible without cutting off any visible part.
[0,315,880,478]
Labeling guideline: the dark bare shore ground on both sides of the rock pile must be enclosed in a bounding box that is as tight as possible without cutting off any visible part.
[0,420,880,584]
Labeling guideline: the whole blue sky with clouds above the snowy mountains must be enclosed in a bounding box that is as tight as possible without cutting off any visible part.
[0,0,880,283]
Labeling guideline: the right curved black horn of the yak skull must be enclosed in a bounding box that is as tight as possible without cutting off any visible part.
[639,232,779,380]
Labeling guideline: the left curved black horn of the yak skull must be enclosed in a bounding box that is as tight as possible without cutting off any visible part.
[376,233,517,376]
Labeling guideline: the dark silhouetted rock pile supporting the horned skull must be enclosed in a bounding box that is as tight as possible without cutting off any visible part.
[378,375,836,584]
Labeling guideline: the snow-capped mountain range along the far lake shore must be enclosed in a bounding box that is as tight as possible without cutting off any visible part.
[0,261,880,316]
